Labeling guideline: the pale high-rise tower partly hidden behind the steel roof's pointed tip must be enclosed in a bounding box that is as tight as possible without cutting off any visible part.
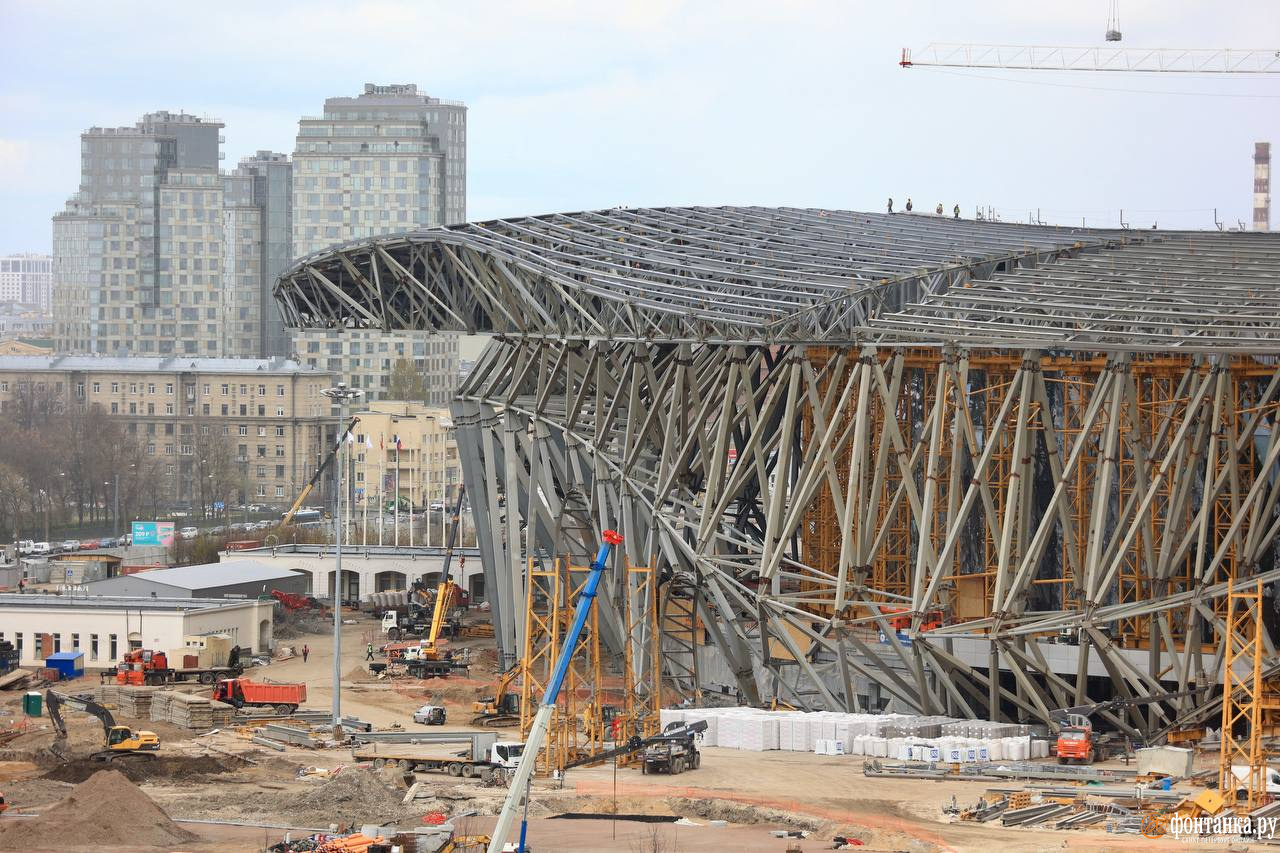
[293,83,467,403]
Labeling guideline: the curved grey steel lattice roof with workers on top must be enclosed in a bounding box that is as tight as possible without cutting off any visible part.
[276,207,1280,352]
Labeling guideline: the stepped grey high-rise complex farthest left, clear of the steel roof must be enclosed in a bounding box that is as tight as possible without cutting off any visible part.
[52,111,289,357]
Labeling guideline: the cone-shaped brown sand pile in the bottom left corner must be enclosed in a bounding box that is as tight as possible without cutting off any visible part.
[0,770,197,850]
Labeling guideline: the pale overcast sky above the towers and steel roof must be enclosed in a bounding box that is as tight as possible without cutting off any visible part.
[0,0,1280,252]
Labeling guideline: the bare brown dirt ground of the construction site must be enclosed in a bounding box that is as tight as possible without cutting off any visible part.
[0,616,1228,853]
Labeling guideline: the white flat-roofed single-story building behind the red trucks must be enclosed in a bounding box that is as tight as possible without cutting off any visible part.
[0,593,275,670]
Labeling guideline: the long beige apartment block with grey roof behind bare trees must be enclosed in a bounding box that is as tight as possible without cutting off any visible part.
[0,356,335,506]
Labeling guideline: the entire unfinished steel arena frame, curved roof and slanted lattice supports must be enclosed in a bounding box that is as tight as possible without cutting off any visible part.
[276,207,1280,739]
